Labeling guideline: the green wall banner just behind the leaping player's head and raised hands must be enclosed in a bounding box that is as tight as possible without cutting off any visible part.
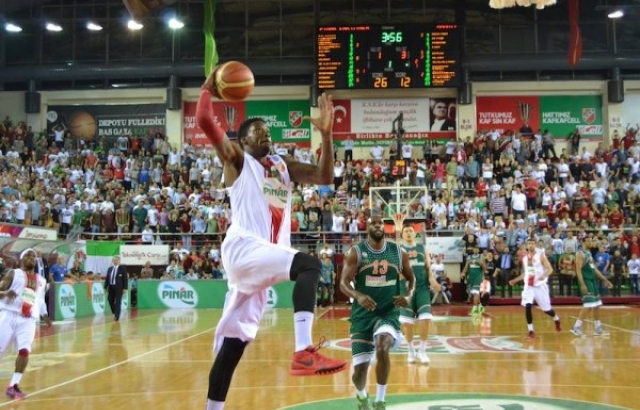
[246,100,311,143]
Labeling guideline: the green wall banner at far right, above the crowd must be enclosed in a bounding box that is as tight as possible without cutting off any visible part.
[534,95,604,138]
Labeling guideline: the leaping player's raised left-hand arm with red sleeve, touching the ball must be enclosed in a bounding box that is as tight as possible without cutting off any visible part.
[196,70,242,165]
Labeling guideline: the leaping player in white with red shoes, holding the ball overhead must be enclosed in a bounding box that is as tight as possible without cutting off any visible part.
[196,74,346,410]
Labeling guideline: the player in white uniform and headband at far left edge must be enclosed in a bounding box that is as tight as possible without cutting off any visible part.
[0,249,51,399]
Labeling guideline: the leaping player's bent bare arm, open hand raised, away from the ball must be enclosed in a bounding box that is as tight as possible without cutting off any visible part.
[285,93,334,185]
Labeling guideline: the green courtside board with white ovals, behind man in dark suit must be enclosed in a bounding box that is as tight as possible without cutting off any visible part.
[53,282,130,320]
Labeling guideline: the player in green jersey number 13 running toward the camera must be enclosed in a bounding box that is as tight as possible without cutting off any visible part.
[340,212,415,410]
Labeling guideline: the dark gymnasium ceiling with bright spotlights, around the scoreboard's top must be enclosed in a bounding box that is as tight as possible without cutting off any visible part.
[0,0,640,88]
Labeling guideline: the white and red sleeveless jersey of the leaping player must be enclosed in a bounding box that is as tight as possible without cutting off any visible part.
[227,153,291,246]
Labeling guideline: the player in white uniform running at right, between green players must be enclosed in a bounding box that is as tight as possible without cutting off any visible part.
[509,238,562,339]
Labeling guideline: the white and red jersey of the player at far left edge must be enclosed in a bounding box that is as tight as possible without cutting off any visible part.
[0,269,47,318]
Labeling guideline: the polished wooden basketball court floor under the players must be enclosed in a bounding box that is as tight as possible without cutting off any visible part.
[0,306,640,410]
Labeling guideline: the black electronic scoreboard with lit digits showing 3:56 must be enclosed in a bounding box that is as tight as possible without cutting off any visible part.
[316,24,460,90]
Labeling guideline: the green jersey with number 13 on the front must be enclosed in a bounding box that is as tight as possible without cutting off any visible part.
[351,241,402,322]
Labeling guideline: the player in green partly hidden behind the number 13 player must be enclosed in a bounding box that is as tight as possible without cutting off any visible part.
[400,225,440,364]
